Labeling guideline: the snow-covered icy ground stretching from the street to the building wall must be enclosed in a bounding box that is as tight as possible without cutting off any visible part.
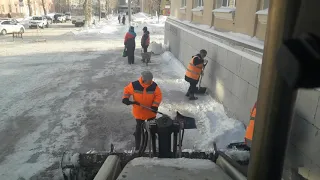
[0,14,244,180]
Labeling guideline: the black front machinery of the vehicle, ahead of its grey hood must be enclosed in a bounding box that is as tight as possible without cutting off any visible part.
[60,112,249,180]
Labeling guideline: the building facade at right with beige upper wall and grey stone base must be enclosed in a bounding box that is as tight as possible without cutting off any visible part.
[164,0,320,180]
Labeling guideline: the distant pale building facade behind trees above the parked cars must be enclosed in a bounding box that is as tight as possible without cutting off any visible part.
[0,0,55,17]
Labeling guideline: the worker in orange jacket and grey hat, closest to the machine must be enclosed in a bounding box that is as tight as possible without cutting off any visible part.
[122,71,162,150]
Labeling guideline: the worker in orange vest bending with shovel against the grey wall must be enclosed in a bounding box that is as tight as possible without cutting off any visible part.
[185,49,207,100]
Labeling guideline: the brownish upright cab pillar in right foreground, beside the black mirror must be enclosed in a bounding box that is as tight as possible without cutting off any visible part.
[248,0,301,180]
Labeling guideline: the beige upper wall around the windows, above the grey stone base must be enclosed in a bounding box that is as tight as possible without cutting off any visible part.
[171,0,266,40]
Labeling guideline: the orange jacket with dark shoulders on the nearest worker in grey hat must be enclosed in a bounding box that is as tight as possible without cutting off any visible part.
[123,78,162,120]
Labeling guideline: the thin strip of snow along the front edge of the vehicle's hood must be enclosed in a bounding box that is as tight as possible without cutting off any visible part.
[129,157,217,170]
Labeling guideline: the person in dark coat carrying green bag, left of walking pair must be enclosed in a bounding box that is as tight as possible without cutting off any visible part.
[124,26,137,64]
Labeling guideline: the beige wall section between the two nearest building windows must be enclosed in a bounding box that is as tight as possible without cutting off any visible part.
[235,0,260,36]
